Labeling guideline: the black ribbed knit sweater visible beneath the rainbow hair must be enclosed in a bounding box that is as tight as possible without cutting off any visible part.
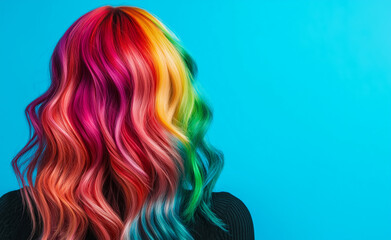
[0,190,254,240]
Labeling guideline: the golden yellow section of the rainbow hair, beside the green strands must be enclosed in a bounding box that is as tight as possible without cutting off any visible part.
[126,8,195,147]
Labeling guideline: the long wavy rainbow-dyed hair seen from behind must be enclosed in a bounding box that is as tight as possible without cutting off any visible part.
[12,6,225,240]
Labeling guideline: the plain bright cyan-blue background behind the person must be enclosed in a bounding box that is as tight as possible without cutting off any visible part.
[0,0,391,240]
